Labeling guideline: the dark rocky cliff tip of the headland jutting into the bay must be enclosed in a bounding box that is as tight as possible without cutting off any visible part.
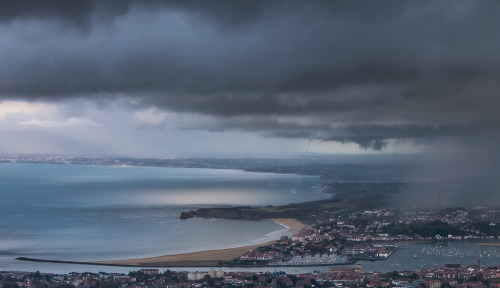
[180,207,267,220]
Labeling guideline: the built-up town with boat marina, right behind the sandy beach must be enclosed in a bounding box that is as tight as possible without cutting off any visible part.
[226,207,500,266]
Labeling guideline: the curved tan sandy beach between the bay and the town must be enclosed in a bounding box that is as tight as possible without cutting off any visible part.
[90,219,305,267]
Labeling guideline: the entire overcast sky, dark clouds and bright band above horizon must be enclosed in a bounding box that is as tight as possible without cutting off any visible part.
[0,0,500,163]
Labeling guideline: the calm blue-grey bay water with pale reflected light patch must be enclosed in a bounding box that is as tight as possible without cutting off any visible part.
[0,164,329,270]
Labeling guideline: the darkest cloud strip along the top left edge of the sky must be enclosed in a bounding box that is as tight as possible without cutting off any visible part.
[0,0,270,28]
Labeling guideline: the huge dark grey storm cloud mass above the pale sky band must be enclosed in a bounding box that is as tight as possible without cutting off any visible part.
[0,0,500,149]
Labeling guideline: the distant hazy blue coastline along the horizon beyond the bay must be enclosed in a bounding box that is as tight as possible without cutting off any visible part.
[0,154,422,182]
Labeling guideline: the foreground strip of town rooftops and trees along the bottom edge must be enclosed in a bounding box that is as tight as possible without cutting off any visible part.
[0,263,500,288]
